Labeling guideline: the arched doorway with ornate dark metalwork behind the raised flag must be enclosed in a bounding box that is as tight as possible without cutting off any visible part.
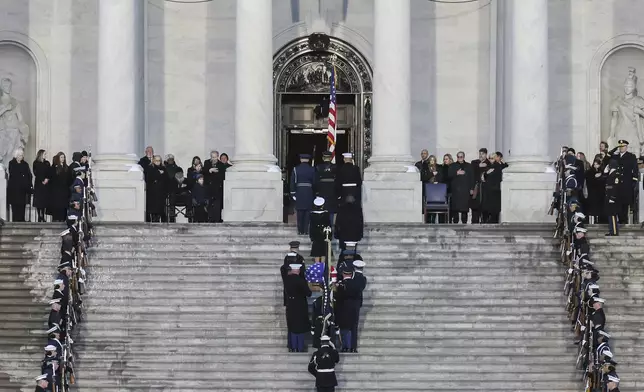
[273,33,372,178]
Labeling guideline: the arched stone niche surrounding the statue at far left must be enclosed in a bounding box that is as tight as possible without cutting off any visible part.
[0,42,36,166]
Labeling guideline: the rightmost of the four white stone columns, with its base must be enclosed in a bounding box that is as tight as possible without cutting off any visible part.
[501,0,556,222]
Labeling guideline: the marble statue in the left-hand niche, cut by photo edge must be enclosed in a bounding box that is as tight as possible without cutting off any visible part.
[0,78,29,166]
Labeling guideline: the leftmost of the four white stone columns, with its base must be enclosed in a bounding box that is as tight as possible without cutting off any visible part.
[94,0,145,222]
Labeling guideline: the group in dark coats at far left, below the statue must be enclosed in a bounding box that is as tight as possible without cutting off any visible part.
[7,149,89,222]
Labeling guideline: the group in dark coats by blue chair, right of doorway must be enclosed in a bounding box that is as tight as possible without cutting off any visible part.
[416,148,508,223]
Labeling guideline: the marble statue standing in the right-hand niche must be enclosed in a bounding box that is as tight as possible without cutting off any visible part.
[607,67,644,155]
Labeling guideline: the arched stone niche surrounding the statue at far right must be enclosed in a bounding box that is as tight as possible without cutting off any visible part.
[600,45,644,155]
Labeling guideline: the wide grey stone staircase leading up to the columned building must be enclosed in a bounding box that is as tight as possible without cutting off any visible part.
[0,224,644,392]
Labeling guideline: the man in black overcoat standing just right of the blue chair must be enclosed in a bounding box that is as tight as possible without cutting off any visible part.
[447,151,474,223]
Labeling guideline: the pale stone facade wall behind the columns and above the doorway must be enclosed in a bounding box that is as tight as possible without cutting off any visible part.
[0,0,644,219]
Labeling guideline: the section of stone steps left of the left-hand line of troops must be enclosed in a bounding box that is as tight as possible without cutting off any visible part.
[0,223,64,392]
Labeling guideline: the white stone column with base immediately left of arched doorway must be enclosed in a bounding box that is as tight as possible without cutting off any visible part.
[223,0,283,222]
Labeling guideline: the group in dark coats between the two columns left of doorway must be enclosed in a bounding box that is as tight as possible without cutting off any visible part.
[139,146,232,223]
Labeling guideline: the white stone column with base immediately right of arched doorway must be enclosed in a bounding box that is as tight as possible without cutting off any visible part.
[363,0,422,222]
